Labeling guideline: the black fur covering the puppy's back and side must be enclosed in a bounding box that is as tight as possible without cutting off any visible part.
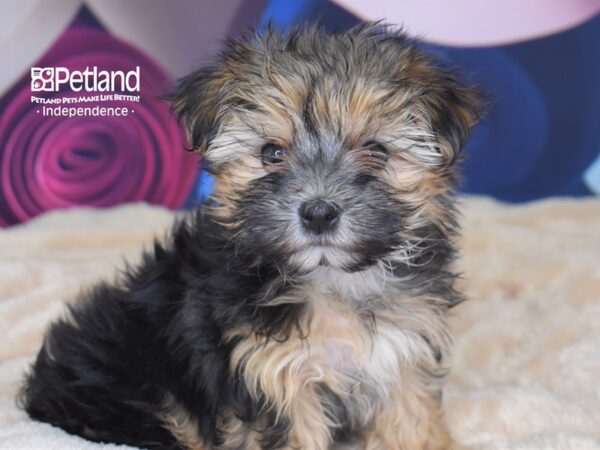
[20,210,301,449]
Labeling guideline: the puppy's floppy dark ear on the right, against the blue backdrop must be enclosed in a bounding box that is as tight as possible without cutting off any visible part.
[427,71,486,167]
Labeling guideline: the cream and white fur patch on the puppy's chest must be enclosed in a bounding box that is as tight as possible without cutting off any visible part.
[234,278,403,402]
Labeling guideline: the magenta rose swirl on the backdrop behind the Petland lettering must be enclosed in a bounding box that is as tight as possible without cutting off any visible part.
[0,23,199,225]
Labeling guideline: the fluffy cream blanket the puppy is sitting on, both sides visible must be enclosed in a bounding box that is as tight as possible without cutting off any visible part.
[0,198,600,450]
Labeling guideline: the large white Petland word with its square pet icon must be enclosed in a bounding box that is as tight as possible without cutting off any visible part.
[31,66,140,92]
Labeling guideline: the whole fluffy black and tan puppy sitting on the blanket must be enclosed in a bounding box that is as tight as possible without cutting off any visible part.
[21,24,479,450]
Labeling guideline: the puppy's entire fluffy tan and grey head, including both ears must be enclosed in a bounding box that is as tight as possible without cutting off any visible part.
[174,25,477,272]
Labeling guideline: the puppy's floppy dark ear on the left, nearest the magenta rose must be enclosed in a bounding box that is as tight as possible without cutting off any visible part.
[169,67,228,155]
